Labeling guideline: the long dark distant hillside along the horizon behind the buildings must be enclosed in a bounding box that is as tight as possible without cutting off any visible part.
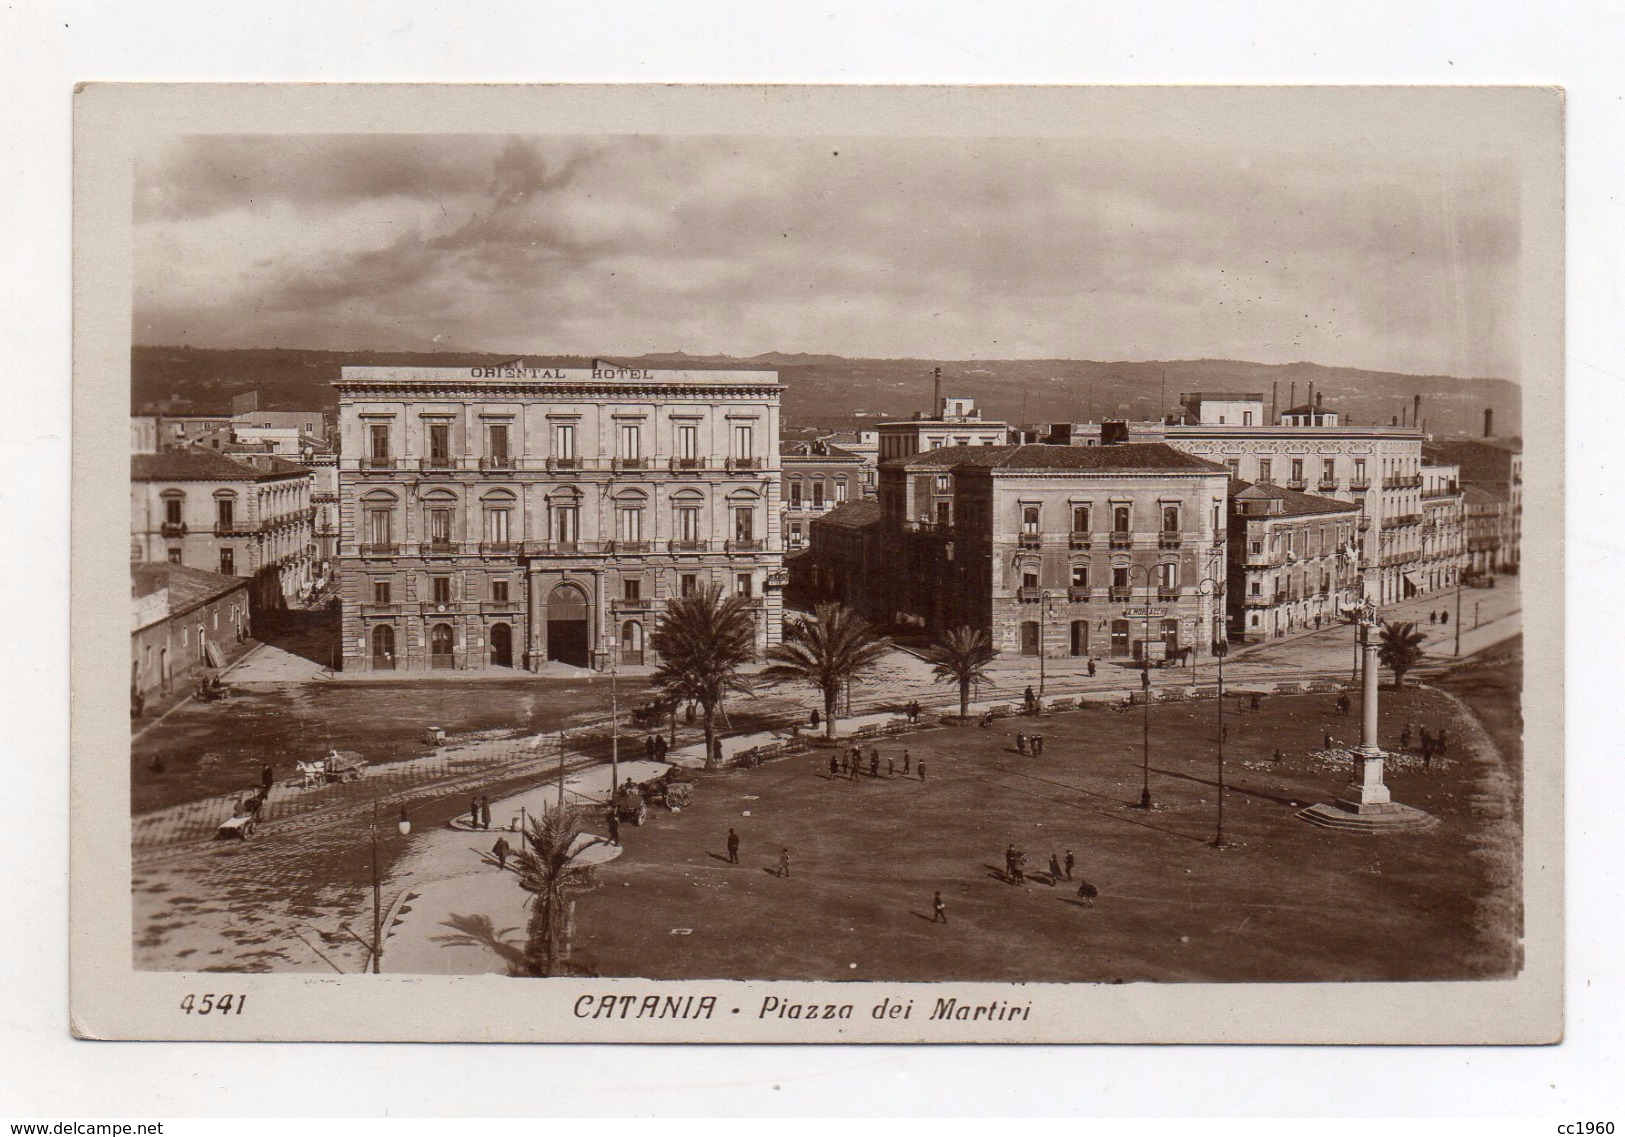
[130,346,1521,435]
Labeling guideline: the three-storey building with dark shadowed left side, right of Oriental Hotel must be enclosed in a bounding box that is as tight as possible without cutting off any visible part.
[814,443,1227,658]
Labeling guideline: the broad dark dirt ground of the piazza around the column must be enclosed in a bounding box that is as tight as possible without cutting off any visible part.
[575,678,1516,983]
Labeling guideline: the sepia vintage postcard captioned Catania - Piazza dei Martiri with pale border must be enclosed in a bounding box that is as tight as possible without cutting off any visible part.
[72,84,1563,1043]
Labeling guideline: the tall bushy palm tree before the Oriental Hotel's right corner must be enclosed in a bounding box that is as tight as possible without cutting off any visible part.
[648,585,756,767]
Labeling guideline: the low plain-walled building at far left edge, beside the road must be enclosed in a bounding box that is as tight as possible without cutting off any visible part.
[130,560,249,698]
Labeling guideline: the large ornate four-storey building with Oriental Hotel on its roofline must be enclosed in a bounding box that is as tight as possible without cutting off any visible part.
[335,361,785,671]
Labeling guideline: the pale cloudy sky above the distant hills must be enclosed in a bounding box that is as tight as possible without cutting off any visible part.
[133,135,1519,380]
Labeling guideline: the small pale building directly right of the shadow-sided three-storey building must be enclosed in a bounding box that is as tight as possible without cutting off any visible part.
[1225,481,1362,643]
